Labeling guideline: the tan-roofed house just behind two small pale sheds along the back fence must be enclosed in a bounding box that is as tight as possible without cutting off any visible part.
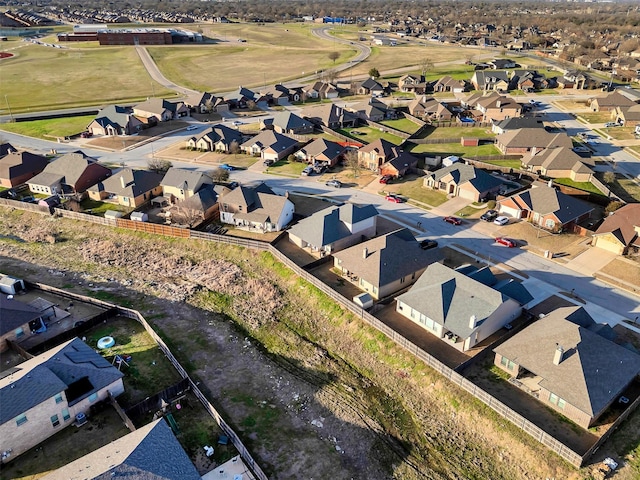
[87,168,163,208]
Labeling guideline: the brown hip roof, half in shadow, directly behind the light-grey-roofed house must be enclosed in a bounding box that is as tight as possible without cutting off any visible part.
[333,228,443,286]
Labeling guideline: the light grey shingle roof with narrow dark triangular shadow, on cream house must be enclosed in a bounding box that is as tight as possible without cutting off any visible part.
[398,263,509,338]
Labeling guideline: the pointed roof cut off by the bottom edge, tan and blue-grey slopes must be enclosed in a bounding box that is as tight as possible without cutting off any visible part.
[43,418,202,480]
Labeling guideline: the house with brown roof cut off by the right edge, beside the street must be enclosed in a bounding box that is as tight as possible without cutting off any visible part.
[591,203,640,255]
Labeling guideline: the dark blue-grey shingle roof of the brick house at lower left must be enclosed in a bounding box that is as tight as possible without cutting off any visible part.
[0,338,123,424]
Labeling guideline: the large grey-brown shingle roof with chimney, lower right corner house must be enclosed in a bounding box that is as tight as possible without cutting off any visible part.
[494,307,640,416]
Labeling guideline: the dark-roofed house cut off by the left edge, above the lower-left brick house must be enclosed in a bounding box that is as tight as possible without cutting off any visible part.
[0,294,46,352]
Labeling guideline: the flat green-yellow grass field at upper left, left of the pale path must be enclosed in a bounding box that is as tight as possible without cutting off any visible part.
[2,44,173,114]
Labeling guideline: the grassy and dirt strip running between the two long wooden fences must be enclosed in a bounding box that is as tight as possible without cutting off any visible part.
[0,209,640,480]
